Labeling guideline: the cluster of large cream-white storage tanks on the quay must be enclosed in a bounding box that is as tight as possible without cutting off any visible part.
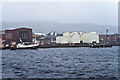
[56,32,99,44]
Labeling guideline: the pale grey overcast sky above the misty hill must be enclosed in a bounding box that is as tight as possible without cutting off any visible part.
[2,2,118,26]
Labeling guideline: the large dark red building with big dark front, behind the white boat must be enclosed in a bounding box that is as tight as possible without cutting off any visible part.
[5,28,32,43]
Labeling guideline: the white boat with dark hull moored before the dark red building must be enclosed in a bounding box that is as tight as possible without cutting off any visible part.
[10,42,39,50]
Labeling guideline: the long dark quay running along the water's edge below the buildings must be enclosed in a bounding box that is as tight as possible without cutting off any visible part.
[0,44,117,50]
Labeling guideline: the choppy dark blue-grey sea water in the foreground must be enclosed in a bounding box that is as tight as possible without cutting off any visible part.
[2,47,118,78]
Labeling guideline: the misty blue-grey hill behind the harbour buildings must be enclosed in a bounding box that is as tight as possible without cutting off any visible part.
[2,21,118,34]
